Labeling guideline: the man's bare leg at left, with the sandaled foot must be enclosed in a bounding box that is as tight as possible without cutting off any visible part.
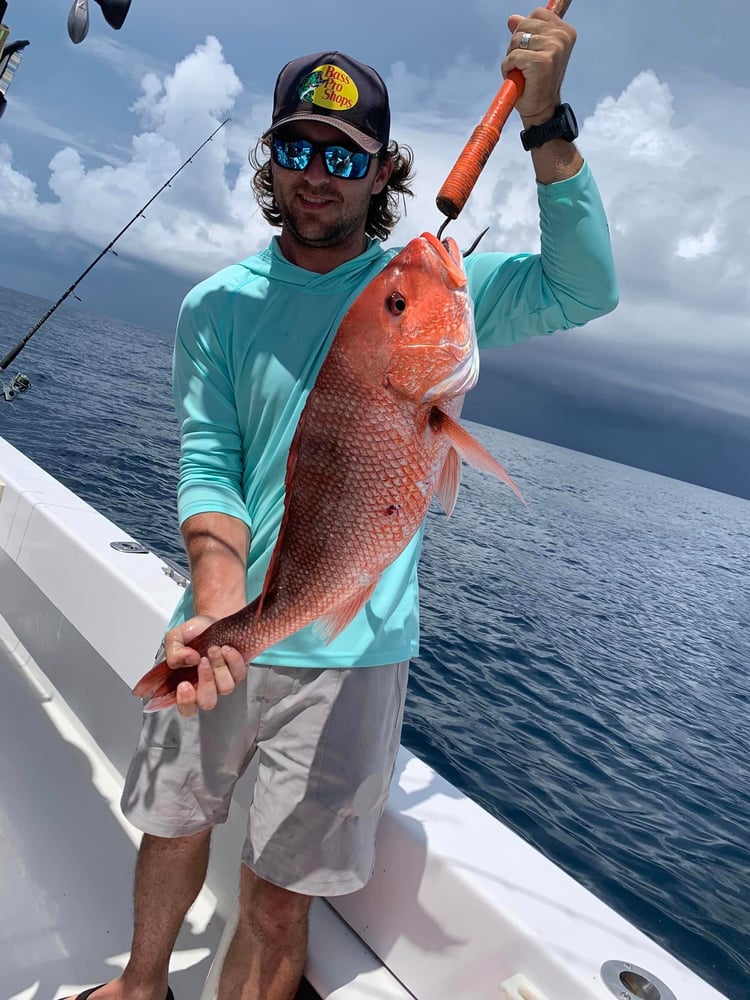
[65,830,211,1000]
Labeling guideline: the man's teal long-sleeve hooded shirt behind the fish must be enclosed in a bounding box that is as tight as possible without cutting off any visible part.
[170,164,617,668]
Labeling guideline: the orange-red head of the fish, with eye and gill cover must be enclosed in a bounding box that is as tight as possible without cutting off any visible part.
[347,233,479,403]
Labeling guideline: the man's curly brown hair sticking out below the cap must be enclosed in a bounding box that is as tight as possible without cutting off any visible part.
[248,138,414,240]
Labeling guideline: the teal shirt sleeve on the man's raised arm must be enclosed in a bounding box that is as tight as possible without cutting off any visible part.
[466,163,619,347]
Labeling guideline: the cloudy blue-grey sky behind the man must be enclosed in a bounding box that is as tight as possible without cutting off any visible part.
[0,0,750,492]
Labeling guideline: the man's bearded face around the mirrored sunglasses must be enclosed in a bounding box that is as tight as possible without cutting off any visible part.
[271,122,391,252]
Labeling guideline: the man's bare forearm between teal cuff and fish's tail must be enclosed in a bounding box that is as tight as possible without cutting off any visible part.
[182,512,250,618]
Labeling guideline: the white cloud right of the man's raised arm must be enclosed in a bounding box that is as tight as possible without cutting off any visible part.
[582,72,750,320]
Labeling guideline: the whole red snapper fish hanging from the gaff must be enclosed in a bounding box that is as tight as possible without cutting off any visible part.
[133,233,523,711]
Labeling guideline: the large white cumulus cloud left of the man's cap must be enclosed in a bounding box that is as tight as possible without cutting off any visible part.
[0,37,264,278]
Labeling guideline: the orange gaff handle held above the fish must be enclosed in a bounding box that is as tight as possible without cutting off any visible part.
[435,0,572,219]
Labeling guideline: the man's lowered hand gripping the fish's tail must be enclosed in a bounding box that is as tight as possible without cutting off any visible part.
[164,615,247,718]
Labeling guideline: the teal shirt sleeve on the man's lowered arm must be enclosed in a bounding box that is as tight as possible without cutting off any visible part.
[172,285,252,528]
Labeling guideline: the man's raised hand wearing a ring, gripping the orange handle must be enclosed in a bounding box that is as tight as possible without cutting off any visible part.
[502,7,576,128]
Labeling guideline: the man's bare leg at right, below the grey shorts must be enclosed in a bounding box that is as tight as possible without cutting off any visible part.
[218,865,312,1000]
